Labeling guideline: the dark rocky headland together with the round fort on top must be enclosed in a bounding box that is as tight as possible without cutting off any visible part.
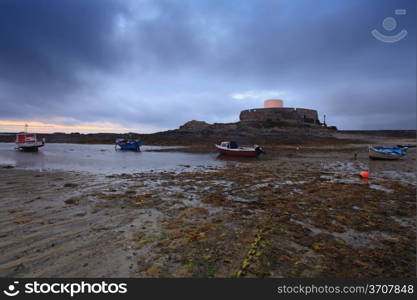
[0,99,416,145]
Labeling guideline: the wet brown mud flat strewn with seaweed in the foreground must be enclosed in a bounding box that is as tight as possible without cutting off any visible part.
[0,148,416,278]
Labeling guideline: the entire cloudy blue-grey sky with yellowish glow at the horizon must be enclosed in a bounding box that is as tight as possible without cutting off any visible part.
[0,0,416,132]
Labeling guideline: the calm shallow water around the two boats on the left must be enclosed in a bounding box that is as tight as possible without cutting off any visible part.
[0,143,225,174]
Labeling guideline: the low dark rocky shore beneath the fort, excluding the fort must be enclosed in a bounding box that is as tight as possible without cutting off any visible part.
[0,126,416,148]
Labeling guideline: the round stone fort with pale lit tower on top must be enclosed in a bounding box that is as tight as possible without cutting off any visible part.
[239,99,321,126]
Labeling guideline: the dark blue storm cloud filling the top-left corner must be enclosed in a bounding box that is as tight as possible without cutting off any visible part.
[0,0,124,97]
